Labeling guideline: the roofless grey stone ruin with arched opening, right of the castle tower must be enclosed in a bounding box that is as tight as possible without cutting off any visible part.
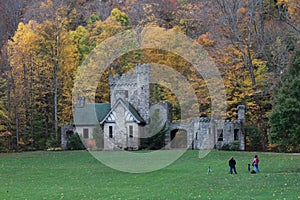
[169,106,245,150]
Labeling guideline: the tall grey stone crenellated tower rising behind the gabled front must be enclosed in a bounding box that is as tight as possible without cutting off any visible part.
[109,64,150,122]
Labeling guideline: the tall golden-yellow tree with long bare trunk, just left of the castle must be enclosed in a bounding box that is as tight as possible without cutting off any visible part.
[32,0,76,142]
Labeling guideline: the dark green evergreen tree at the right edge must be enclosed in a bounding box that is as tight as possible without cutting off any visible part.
[270,50,300,152]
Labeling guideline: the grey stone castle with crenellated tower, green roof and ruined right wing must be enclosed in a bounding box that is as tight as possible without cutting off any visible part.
[62,64,245,150]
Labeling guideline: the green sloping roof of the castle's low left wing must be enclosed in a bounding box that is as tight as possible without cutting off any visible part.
[74,103,110,125]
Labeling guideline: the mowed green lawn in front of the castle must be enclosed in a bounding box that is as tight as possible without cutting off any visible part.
[0,150,300,200]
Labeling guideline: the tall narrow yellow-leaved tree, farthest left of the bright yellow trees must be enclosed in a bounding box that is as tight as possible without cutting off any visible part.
[8,21,36,149]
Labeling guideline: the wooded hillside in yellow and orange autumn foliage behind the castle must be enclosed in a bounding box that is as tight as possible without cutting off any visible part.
[0,0,300,152]
